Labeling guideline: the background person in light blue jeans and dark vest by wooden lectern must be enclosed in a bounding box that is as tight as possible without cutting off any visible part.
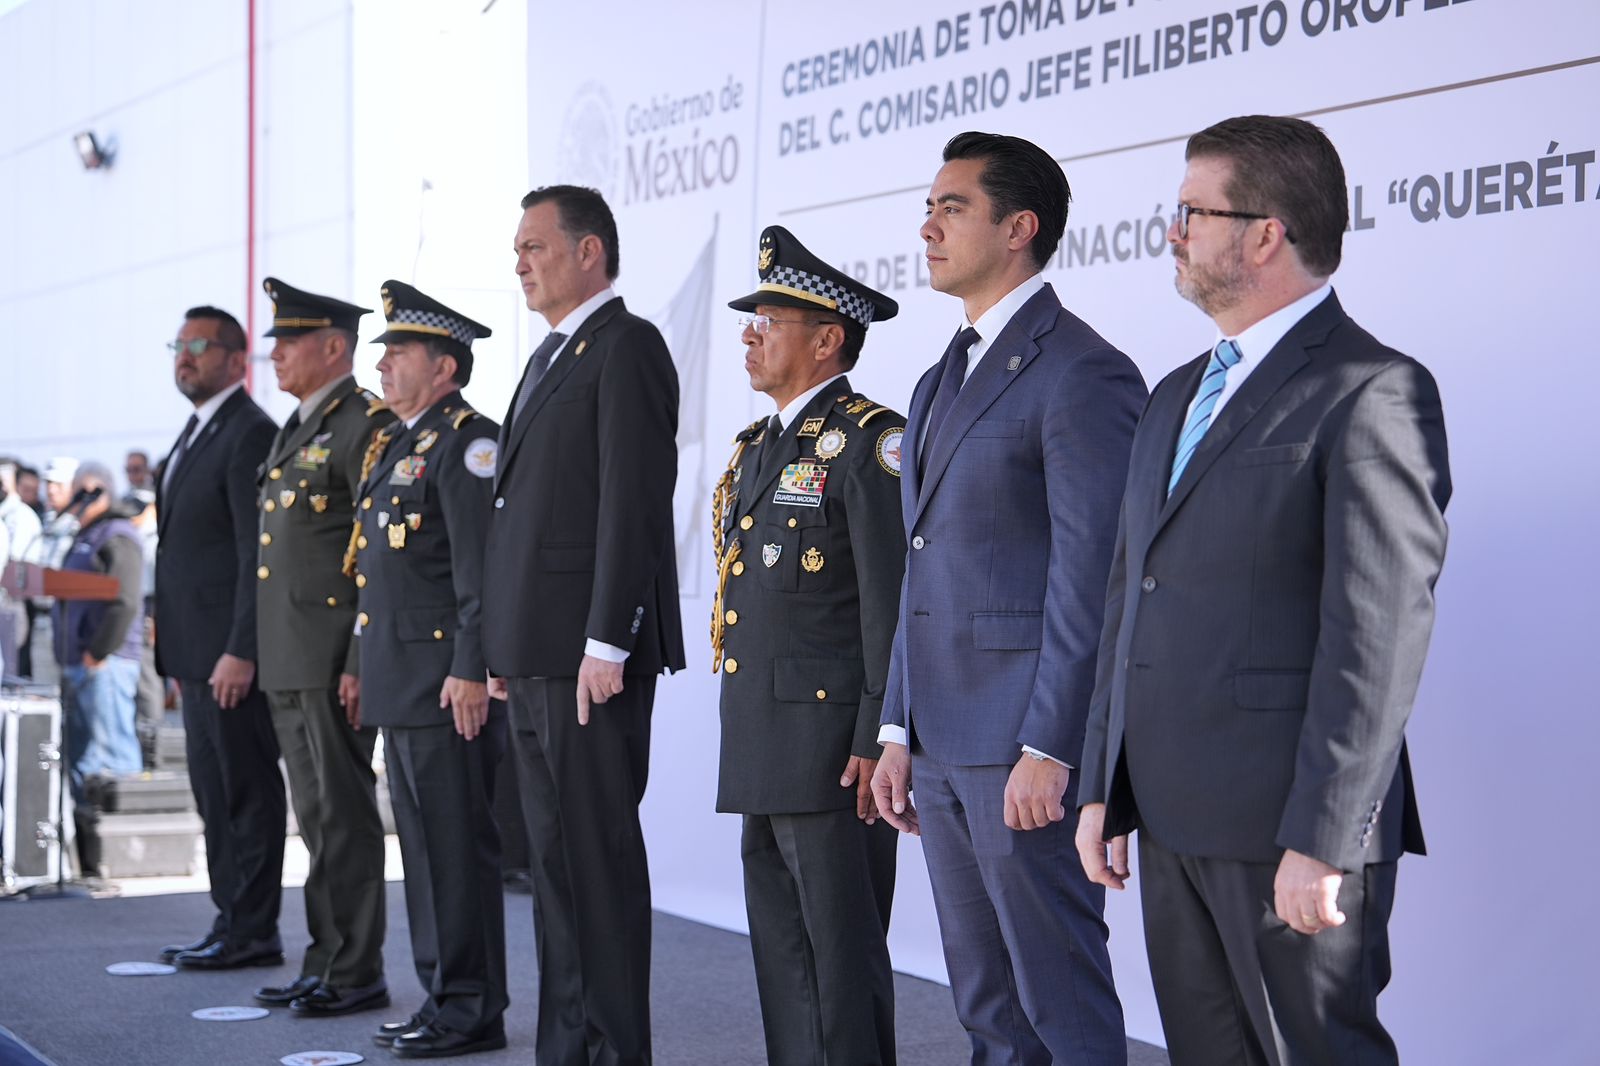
[54,463,144,877]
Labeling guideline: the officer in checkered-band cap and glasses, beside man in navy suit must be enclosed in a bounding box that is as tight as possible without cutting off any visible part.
[712,226,906,1066]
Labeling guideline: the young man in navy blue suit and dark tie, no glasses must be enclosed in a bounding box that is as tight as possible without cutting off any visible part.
[872,133,1146,1064]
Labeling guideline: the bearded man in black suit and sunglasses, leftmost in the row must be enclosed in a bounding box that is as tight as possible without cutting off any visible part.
[155,307,286,968]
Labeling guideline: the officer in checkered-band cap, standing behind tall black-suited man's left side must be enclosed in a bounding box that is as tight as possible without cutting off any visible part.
[355,282,509,1058]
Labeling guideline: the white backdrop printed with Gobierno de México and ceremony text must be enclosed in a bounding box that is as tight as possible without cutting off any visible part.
[528,0,1600,1063]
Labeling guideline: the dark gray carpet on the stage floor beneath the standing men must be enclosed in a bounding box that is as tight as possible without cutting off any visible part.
[0,884,1166,1066]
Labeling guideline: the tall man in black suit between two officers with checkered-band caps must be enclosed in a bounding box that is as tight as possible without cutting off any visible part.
[483,186,683,1066]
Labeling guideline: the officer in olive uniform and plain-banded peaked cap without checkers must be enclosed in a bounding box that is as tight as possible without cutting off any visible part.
[256,277,394,1016]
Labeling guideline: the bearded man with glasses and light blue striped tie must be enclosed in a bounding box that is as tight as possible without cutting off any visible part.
[1077,115,1450,1066]
